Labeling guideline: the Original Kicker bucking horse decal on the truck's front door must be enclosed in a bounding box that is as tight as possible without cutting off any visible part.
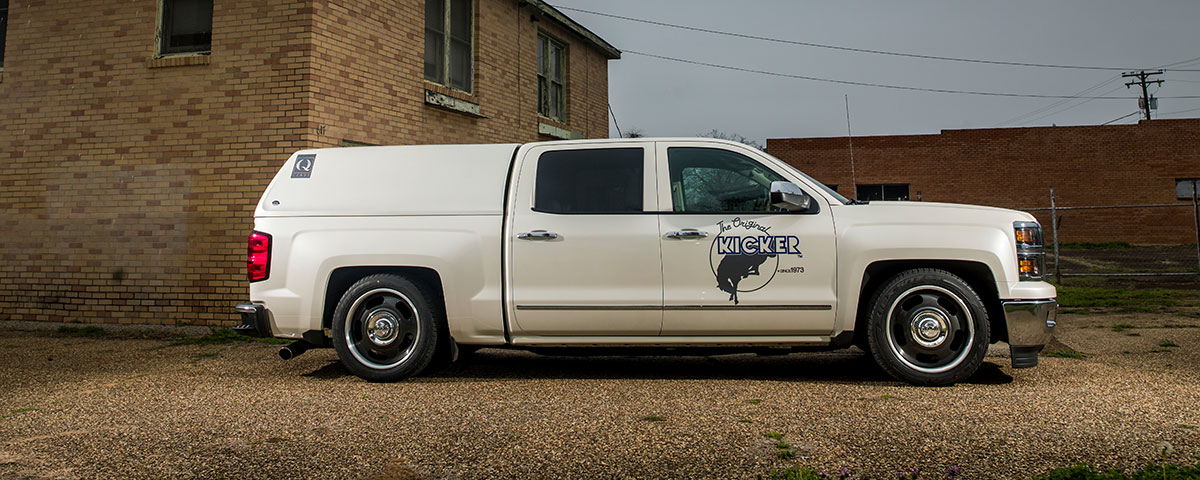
[708,217,804,305]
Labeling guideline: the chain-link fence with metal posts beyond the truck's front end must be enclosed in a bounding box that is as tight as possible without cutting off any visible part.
[1025,188,1200,281]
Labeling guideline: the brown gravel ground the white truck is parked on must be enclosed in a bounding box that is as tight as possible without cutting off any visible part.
[0,313,1200,479]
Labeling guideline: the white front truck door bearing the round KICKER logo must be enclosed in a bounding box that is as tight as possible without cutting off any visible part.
[656,142,836,336]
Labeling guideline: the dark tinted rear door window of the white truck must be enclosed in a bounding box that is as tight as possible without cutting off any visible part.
[533,148,646,214]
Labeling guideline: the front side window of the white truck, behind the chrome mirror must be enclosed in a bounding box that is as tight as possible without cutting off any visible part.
[667,146,784,214]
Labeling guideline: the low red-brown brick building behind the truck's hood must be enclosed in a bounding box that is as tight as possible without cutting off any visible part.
[767,119,1200,244]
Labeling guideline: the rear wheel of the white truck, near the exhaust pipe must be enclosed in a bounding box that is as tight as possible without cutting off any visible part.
[332,274,440,382]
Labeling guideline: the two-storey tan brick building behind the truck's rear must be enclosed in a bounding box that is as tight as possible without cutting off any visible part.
[0,0,620,325]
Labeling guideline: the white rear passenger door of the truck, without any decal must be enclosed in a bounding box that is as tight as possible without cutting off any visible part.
[506,142,662,336]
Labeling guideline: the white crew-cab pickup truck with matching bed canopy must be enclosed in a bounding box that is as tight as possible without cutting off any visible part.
[235,138,1057,385]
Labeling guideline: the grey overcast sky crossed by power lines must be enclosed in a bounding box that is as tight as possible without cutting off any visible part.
[550,0,1200,142]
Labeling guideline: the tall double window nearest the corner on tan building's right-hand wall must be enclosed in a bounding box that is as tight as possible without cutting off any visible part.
[425,0,475,91]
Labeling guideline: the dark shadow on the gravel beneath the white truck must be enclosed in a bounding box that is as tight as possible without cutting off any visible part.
[304,349,1013,385]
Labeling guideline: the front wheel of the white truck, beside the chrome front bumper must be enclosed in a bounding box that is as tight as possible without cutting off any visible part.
[868,269,990,385]
